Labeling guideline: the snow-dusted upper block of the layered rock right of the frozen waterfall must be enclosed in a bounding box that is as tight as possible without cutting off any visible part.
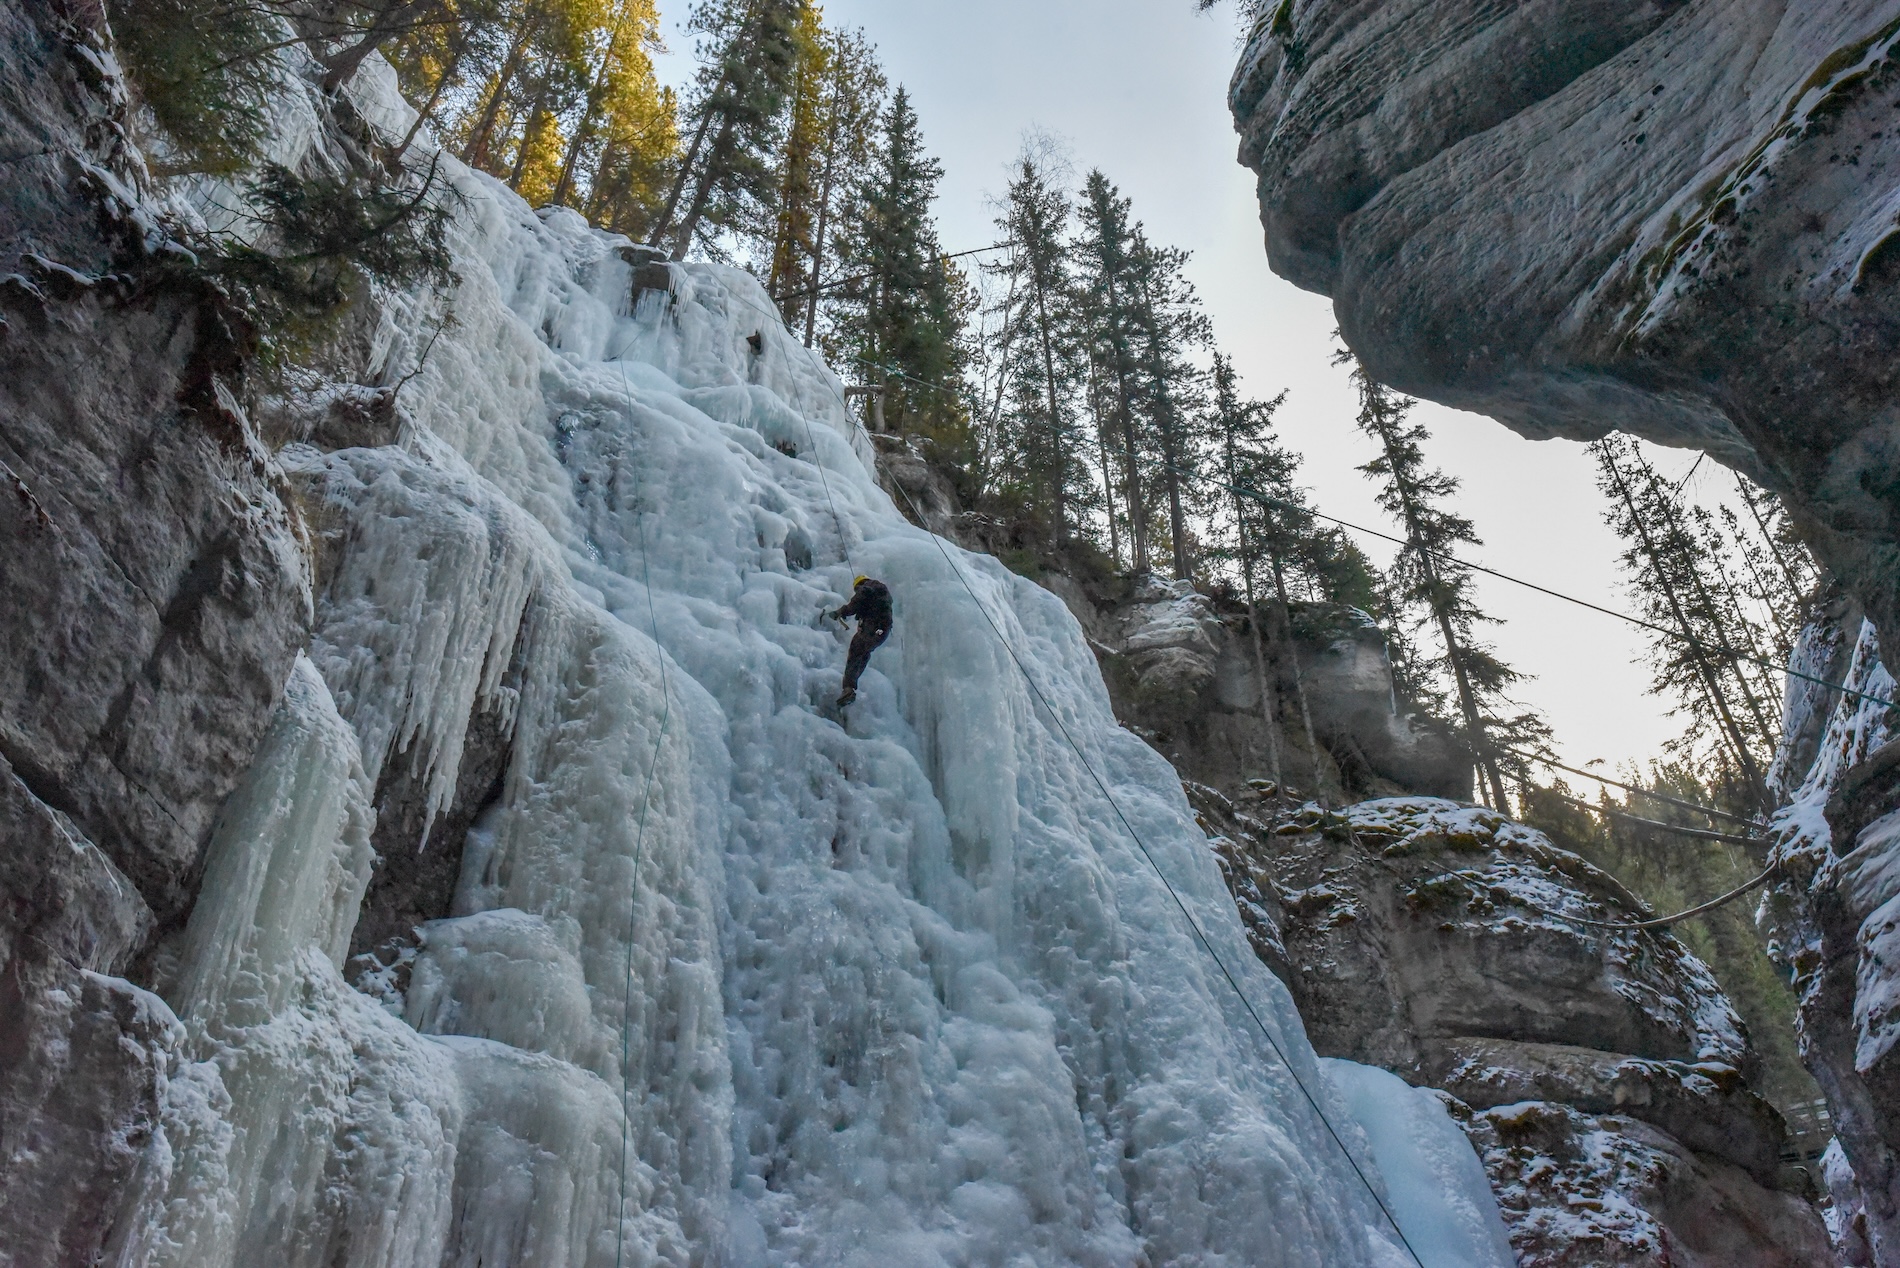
[1258,798,1750,1084]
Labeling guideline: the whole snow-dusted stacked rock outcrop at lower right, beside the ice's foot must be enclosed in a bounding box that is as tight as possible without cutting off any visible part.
[1197,789,1830,1268]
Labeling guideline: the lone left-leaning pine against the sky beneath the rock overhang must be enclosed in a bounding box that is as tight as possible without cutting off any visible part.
[1340,354,1549,810]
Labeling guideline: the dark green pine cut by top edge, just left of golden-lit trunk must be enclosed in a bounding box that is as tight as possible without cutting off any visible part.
[656,0,809,260]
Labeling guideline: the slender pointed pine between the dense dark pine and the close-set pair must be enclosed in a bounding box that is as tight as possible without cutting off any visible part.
[990,154,1096,546]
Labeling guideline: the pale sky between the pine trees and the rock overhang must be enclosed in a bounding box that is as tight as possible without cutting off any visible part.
[663,0,1731,766]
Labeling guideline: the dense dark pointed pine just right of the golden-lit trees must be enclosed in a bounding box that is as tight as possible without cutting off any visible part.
[828,87,971,464]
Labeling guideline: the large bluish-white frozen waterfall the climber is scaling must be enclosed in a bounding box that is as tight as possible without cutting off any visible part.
[118,64,1509,1268]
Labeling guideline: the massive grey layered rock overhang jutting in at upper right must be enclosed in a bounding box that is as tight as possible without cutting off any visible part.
[1231,0,1900,629]
